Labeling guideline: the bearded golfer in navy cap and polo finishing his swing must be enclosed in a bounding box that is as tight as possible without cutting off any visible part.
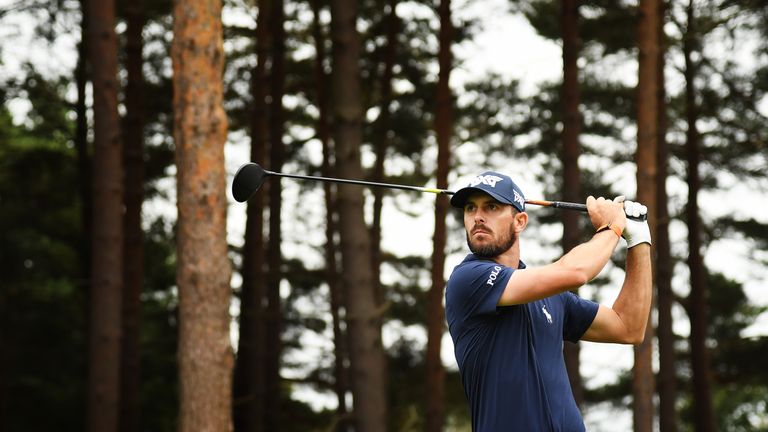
[445,171,651,432]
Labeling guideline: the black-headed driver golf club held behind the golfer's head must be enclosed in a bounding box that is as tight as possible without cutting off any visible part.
[232,163,646,220]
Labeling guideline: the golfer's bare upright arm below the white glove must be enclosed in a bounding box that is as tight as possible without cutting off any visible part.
[582,243,652,344]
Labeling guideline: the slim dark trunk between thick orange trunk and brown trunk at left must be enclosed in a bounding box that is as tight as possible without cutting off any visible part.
[120,2,146,432]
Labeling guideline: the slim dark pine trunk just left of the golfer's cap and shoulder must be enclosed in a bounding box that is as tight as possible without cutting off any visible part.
[424,0,453,432]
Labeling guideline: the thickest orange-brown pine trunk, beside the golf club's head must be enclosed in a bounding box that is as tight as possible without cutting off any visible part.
[171,0,232,432]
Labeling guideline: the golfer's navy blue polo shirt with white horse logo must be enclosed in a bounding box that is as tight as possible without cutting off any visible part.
[445,254,599,432]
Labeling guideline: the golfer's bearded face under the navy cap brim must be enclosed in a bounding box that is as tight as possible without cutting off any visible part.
[464,192,517,258]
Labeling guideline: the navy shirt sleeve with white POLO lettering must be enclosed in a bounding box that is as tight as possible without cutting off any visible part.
[445,261,514,321]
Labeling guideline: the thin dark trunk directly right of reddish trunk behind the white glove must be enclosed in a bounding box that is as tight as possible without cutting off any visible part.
[656,1,678,432]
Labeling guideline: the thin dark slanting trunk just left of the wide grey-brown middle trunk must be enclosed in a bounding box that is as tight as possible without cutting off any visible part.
[312,0,350,432]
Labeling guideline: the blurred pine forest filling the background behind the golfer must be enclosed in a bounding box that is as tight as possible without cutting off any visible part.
[0,0,768,431]
